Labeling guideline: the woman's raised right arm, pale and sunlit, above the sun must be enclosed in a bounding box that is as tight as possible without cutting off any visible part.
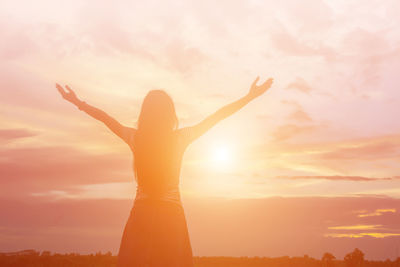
[182,77,273,146]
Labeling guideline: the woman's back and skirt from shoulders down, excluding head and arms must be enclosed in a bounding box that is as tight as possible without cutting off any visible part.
[117,128,194,267]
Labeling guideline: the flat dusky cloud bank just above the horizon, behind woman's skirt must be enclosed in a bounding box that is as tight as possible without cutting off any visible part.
[0,197,400,259]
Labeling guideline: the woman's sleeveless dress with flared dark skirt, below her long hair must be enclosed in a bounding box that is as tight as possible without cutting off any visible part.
[117,128,194,267]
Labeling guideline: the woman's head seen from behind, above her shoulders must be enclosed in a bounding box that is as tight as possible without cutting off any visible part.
[138,90,178,133]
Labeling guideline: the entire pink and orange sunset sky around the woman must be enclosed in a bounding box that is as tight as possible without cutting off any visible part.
[0,0,400,259]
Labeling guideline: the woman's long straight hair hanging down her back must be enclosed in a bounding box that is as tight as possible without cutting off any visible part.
[134,90,178,186]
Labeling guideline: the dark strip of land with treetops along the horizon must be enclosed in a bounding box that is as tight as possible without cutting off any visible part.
[0,249,400,267]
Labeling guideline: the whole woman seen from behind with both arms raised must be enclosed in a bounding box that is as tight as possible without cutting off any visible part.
[56,77,273,267]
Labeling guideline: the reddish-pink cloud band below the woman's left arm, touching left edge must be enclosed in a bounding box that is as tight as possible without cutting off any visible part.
[0,146,134,197]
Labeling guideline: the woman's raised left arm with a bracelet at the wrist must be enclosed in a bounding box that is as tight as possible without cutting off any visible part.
[56,84,136,144]
